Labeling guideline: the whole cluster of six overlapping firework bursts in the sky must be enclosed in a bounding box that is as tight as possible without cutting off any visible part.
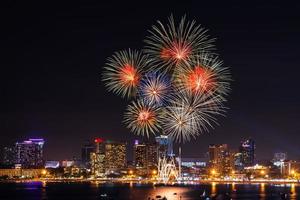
[102,16,231,142]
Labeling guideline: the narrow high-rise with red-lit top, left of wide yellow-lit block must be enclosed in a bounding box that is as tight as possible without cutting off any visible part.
[90,138,105,177]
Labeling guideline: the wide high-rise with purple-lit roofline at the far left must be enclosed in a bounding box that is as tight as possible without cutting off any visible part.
[16,139,45,168]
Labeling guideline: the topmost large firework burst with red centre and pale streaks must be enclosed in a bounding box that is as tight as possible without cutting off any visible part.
[145,16,214,70]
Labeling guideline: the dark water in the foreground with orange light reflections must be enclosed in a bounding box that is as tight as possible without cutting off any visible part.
[0,182,300,200]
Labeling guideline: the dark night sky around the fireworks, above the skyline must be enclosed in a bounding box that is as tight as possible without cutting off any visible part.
[0,0,300,159]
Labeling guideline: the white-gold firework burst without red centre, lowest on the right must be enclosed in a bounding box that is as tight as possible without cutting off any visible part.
[162,91,224,142]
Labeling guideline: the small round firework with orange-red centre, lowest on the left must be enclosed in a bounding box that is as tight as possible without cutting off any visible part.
[124,101,161,137]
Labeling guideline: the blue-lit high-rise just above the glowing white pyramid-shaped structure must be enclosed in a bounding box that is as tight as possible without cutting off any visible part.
[155,135,174,157]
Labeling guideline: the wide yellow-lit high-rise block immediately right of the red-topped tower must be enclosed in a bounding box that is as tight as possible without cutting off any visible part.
[105,141,126,173]
